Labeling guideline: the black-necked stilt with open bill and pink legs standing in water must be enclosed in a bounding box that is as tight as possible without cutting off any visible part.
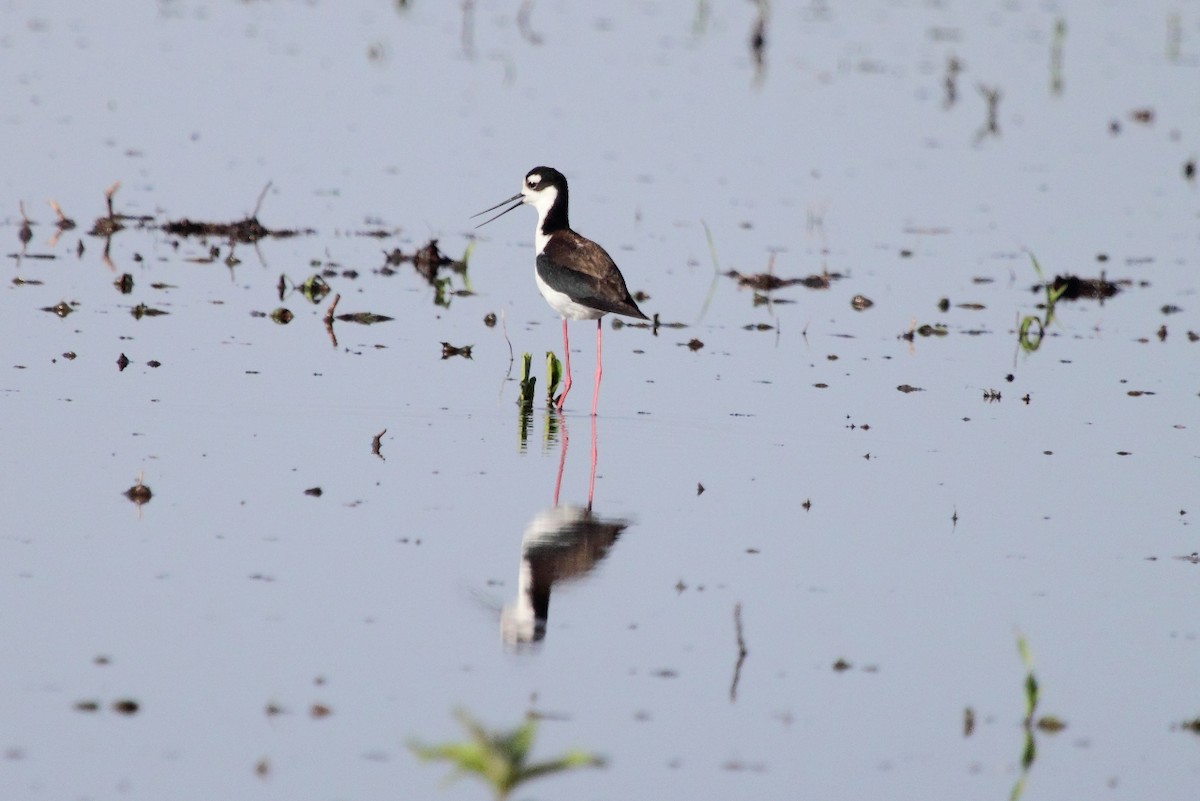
[475,167,649,416]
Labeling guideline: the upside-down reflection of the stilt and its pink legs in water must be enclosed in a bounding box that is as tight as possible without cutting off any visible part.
[500,412,629,648]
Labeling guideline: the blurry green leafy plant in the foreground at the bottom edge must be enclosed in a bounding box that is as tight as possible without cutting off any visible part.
[408,710,604,801]
